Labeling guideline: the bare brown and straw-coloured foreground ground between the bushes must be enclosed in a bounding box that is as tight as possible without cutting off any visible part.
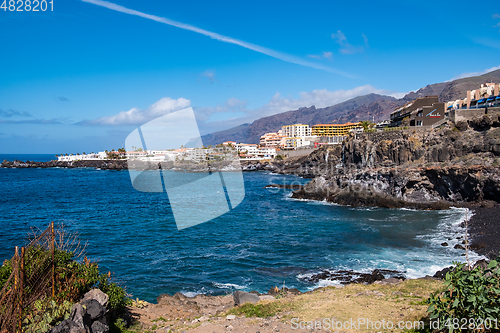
[122,278,442,333]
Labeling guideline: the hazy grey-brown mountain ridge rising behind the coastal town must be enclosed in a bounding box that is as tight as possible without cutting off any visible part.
[202,70,500,145]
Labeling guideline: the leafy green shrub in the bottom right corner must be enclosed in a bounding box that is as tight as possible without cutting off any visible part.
[427,259,500,332]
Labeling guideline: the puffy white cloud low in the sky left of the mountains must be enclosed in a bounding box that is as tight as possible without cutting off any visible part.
[78,97,191,126]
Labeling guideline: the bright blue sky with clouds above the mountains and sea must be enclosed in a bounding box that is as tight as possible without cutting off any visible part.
[0,0,500,154]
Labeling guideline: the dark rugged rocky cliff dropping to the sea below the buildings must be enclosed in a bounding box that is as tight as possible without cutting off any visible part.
[288,115,500,209]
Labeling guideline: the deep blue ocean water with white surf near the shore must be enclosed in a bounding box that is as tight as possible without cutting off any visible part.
[0,168,477,301]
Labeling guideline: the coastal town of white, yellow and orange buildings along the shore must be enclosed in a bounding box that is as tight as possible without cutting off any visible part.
[56,83,500,162]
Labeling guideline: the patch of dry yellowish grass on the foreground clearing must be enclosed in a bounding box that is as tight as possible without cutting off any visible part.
[225,279,443,332]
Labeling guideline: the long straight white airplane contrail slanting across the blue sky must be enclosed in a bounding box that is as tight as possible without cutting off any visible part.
[82,0,355,78]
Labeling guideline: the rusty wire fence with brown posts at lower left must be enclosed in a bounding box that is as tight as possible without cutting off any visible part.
[0,222,57,333]
